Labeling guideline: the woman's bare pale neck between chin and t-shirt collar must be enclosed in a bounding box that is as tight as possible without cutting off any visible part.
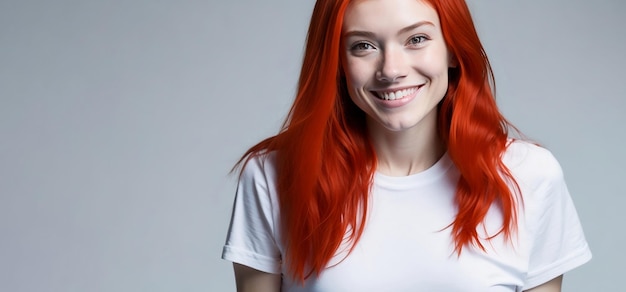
[368,112,446,176]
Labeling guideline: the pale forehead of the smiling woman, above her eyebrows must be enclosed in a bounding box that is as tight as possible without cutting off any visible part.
[343,0,439,31]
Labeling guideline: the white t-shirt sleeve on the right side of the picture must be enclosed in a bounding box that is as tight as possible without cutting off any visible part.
[524,149,591,289]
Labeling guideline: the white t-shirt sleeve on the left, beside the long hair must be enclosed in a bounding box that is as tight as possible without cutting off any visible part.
[222,156,281,274]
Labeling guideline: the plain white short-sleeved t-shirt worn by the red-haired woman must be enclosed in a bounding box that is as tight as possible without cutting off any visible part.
[222,141,591,292]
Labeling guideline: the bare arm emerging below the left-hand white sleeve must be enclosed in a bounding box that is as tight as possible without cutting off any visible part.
[233,263,280,292]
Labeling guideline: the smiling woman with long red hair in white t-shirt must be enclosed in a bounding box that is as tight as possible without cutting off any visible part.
[222,0,591,291]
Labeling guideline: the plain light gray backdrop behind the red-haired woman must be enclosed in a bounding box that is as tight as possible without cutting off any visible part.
[0,0,626,292]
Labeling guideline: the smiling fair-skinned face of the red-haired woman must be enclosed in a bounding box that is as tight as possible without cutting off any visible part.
[342,0,452,131]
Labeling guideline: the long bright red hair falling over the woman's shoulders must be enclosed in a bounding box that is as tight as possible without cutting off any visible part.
[234,0,516,281]
